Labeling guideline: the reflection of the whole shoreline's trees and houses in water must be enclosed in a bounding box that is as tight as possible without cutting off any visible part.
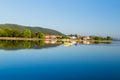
[0,40,111,50]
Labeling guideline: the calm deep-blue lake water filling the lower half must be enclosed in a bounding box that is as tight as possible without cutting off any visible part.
[0,42,120,80]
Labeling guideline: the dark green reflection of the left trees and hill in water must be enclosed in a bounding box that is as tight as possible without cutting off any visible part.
[0,40,58,50]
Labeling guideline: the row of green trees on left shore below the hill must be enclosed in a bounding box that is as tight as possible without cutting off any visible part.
[0,28,44,38]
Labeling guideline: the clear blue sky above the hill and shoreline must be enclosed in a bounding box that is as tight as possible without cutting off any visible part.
[0,0,120,37]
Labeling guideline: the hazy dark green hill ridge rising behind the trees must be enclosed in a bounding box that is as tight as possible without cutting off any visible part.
[0,24,63,35]
